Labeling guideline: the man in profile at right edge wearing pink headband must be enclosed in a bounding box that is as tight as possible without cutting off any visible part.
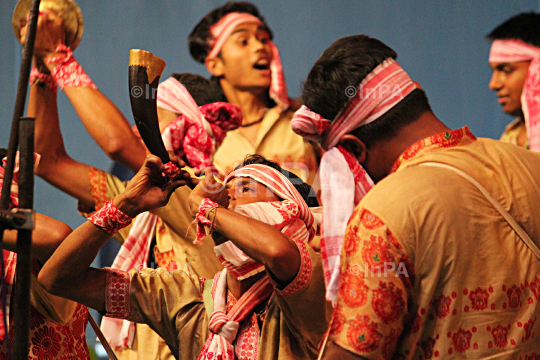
[487,12,540,152]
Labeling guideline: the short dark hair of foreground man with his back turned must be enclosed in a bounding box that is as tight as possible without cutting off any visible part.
[302,35,431,148]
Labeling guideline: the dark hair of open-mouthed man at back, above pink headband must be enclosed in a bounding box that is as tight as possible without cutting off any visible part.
[188,1,273,64]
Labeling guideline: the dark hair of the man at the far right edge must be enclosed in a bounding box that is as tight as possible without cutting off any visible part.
[487,12,540,47]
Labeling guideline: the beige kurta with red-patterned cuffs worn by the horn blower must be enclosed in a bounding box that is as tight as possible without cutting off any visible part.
[101,238,330,360]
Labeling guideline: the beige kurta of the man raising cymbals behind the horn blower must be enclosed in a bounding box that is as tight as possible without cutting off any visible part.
[86,169,222,360]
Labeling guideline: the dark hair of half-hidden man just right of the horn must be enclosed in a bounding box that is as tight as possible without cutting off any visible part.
[171,73,228,106]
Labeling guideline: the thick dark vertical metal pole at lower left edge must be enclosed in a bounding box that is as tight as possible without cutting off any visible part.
[13,118,34,360]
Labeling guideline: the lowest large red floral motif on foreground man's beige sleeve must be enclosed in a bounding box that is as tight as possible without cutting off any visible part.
[347,315,382,353]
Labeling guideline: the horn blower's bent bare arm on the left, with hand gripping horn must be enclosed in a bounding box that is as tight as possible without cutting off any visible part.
[38,154,189,311]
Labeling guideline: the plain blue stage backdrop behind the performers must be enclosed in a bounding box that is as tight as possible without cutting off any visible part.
[0,0,540,232]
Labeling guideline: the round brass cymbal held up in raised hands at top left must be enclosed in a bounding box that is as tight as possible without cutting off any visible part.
[12,0,84,50]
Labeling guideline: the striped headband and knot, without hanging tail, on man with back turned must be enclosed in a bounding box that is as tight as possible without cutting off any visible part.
[291,58,417,150]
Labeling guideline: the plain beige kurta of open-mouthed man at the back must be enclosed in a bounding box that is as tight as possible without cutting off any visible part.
[214,107,319,185]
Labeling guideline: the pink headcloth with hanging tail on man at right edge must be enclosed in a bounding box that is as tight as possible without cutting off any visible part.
[489,39,540,152]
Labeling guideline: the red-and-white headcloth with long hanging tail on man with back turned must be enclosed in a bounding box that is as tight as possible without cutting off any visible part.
[291,58,417,304]
